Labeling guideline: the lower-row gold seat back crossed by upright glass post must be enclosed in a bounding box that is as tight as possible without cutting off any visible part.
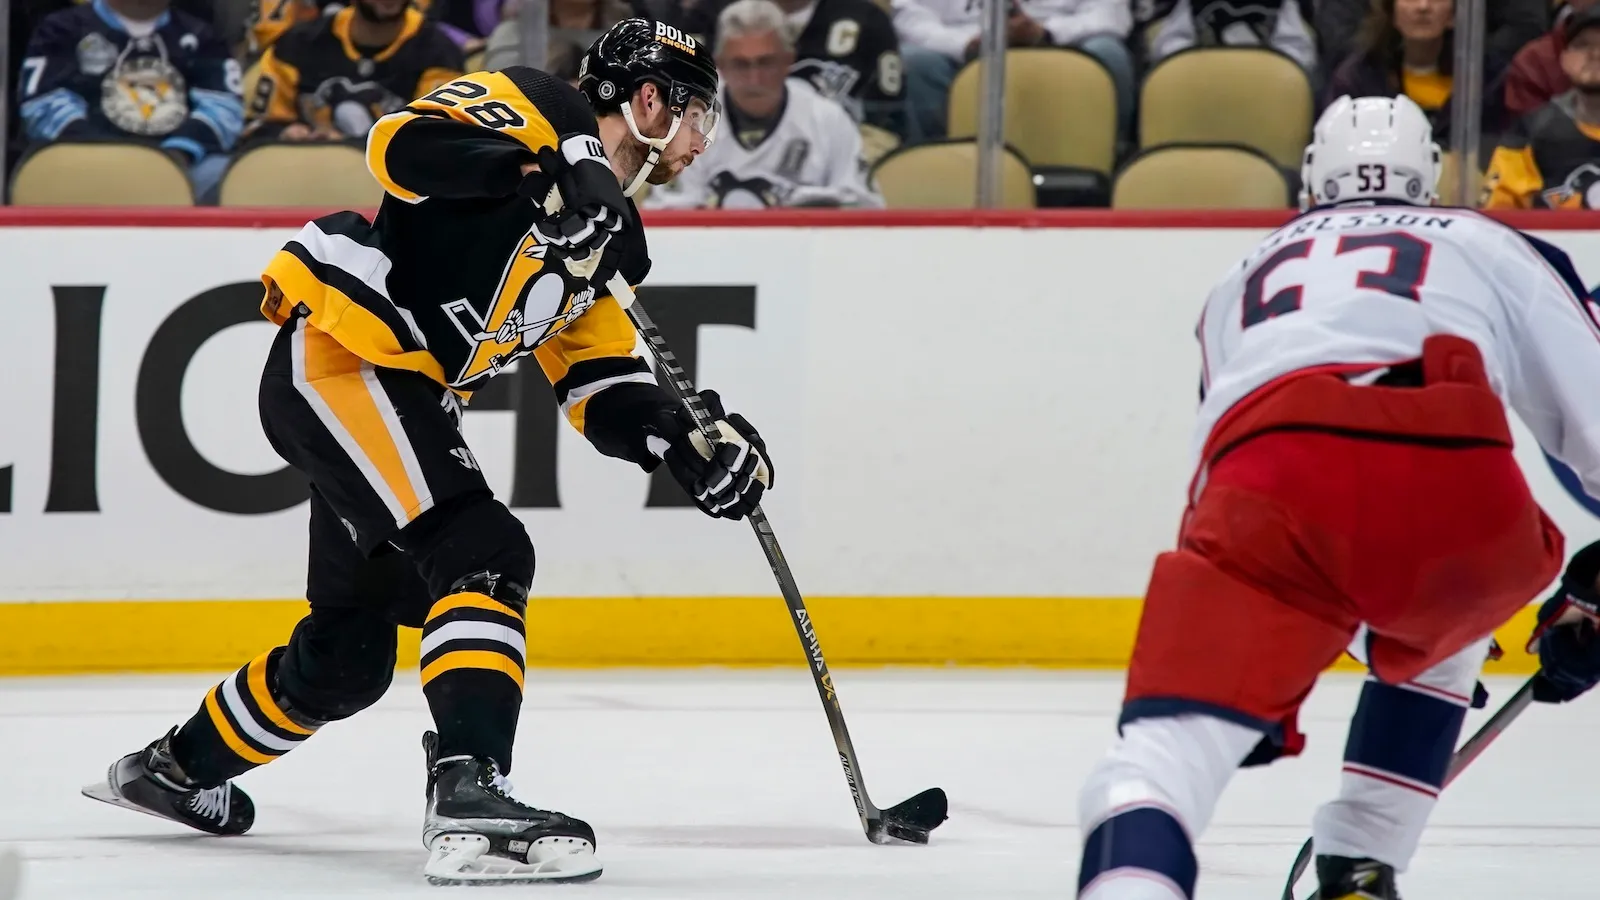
[872,141,1035,210]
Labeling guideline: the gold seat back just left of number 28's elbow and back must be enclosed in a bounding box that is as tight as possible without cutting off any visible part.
[221,144,384,208]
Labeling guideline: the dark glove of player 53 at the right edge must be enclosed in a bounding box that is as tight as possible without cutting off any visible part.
[1530,541,1600,703]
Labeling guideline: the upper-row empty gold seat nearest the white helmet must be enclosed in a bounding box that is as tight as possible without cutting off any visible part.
[1139,46,1312,168]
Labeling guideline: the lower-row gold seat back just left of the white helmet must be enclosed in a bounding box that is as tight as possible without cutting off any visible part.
[1110,146,1290,210]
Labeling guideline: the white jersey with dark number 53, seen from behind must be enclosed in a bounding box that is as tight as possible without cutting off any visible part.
[1190,203,1600,496]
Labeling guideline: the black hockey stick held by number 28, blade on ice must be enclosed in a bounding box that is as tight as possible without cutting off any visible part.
[606,275,949,844]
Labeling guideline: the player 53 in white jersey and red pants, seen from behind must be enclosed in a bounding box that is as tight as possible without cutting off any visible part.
[1078,98,1600,900]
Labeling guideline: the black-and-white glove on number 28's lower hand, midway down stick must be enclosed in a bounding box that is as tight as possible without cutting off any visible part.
[645,391,773,519]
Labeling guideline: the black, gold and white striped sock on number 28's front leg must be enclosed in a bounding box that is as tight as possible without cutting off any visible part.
[422,591,528,772]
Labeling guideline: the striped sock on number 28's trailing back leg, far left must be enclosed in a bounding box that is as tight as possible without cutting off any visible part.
[173,647,322,786]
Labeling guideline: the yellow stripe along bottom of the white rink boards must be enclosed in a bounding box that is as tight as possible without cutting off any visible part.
[0,597,1539,674]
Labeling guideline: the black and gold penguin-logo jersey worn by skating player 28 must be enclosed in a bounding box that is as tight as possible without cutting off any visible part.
[262,66,670,463]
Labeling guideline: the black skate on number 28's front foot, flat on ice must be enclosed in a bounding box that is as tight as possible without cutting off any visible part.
[422,732,602,884]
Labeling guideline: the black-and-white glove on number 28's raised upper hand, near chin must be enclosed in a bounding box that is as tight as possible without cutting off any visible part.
[518,135,632,283]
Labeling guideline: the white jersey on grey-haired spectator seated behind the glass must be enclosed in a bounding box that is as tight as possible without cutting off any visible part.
[645,78,883,210]
